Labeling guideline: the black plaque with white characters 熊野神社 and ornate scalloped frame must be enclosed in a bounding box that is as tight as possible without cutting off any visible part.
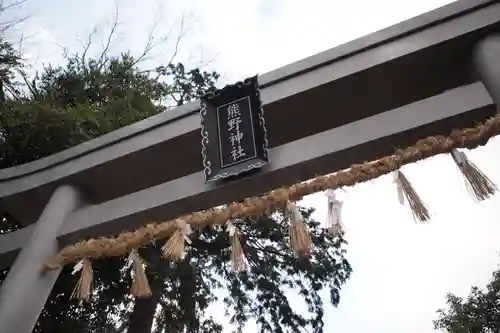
[200,76,269,182]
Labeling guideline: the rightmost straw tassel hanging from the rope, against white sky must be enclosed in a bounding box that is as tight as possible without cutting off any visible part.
[451,149,498,201]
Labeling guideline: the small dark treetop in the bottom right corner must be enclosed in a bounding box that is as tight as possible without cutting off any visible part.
[434,269,500,333]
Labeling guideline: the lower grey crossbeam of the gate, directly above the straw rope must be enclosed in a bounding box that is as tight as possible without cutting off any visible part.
[0,83,495,266]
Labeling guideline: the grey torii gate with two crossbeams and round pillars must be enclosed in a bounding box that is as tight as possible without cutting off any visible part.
[0,0,500,333]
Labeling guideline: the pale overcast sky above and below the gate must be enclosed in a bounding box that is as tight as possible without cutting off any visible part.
[5,0,500,333]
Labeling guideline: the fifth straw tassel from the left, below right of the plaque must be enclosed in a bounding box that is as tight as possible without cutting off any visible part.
[286,201,312,257]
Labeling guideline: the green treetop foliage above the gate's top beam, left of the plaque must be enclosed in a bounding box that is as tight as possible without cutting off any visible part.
[0,54,219,168]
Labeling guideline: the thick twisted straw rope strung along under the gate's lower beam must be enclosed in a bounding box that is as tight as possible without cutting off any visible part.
[46,115,500,269]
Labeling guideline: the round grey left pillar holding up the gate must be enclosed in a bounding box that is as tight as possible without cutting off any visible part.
[0,185,82,333]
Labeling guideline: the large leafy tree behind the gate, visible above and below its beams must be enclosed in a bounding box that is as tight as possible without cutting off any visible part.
[0,36,351,333]
